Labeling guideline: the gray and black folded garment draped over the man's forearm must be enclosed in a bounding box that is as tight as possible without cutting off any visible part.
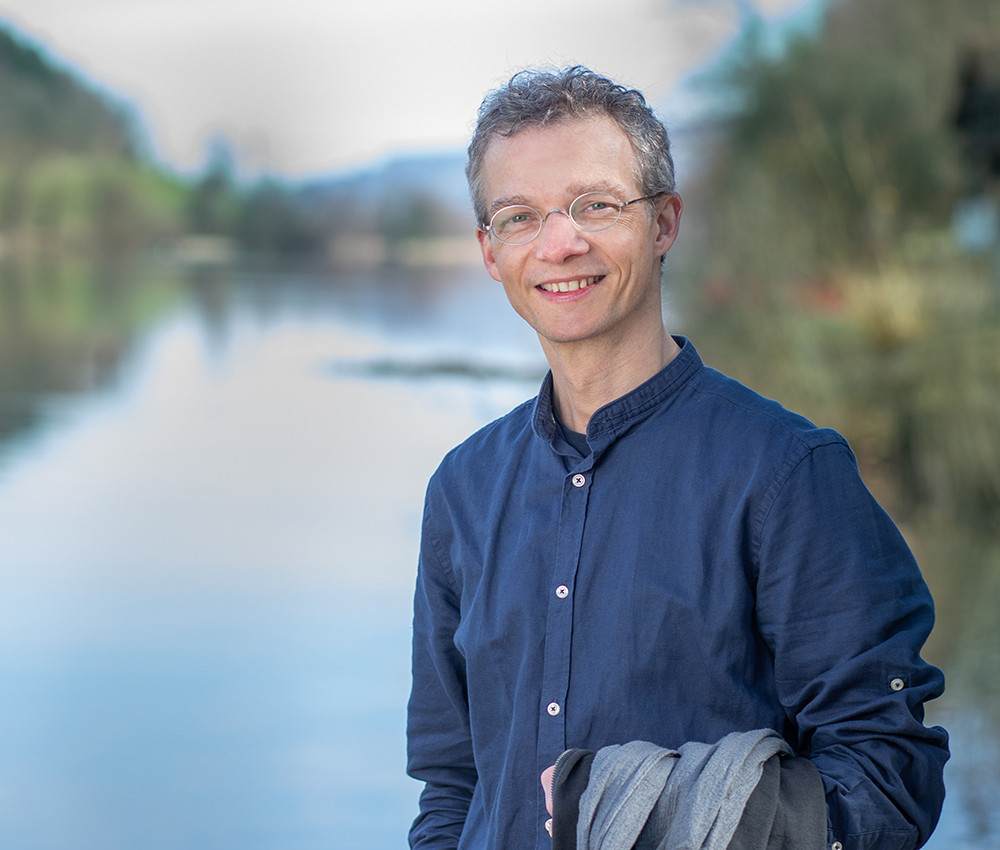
[576,729,827,850]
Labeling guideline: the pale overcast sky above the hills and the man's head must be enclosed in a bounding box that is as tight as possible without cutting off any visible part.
[0,0,810,178]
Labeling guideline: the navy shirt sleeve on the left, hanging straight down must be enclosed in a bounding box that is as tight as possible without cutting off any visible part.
[407,490,477,850]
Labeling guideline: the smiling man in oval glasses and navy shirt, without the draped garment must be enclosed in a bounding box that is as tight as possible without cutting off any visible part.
[408,68,947,850]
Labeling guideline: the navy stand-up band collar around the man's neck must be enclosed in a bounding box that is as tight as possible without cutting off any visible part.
[532,336,703,454]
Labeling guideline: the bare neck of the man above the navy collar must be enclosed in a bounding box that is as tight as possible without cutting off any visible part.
[544,325,680,434]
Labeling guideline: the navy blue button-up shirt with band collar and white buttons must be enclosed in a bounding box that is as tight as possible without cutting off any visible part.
[407,338,948,850]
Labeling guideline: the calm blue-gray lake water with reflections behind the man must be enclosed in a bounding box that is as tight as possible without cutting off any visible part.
[0,268,1000,850]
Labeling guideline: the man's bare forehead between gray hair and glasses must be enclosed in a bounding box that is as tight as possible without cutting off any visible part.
[482,115,639,207]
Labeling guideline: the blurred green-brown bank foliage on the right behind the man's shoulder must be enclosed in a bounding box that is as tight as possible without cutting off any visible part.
[687,0,1000,534]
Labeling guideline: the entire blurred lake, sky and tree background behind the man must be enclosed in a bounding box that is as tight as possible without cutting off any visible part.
[0,0,1000,850]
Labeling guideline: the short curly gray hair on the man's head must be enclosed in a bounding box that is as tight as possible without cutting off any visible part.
[465,65,675,224]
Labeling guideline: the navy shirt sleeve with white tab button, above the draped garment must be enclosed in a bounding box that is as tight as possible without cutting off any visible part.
[754,442,948,850]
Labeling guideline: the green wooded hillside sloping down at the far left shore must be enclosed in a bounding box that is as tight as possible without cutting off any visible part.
[0,27,319,257]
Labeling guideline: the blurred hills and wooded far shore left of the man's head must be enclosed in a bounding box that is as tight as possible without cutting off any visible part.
[0,21,475,265]
